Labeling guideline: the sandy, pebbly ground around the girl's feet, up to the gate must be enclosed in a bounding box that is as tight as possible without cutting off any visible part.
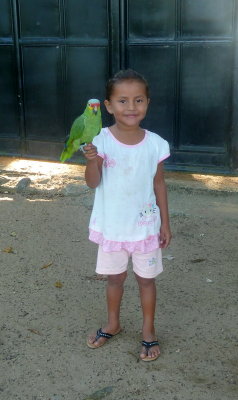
[0,158,238,400]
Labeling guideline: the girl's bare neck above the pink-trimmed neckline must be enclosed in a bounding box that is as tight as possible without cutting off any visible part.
[109,124,145,145]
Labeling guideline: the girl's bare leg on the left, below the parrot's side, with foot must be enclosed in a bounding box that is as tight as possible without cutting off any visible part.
[88,272,127,346]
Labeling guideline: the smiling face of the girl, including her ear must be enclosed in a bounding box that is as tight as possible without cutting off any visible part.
[104,80,149,128]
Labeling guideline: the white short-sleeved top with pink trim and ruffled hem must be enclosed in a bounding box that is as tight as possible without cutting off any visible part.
[89,128,170,253]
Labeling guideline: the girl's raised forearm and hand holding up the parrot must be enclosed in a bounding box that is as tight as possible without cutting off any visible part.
[84,143,103,189]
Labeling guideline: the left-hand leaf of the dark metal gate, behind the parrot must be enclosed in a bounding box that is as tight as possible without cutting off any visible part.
[0,0,113,159]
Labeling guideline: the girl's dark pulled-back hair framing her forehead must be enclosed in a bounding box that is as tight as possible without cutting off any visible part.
[106,69,150,100]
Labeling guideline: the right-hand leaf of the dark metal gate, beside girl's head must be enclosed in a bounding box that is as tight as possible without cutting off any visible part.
[124,0,238,170]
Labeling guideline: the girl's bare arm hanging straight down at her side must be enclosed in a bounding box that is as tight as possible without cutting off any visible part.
[154,162,172,248]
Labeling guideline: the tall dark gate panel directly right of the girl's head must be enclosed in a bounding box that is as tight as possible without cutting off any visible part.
[128,45,176,143]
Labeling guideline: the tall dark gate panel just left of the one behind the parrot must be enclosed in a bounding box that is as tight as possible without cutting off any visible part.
[23,46,64,141]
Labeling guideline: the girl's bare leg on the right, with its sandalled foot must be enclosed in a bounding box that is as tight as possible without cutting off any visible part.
[135,274,160,358]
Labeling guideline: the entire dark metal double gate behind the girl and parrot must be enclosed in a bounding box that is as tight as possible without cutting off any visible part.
[0,0,238,172]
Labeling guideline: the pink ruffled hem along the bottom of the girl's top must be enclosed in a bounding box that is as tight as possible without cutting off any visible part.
[89,229,160,253]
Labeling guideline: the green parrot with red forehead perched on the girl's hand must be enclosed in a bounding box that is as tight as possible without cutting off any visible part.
[60,99,102,162]
